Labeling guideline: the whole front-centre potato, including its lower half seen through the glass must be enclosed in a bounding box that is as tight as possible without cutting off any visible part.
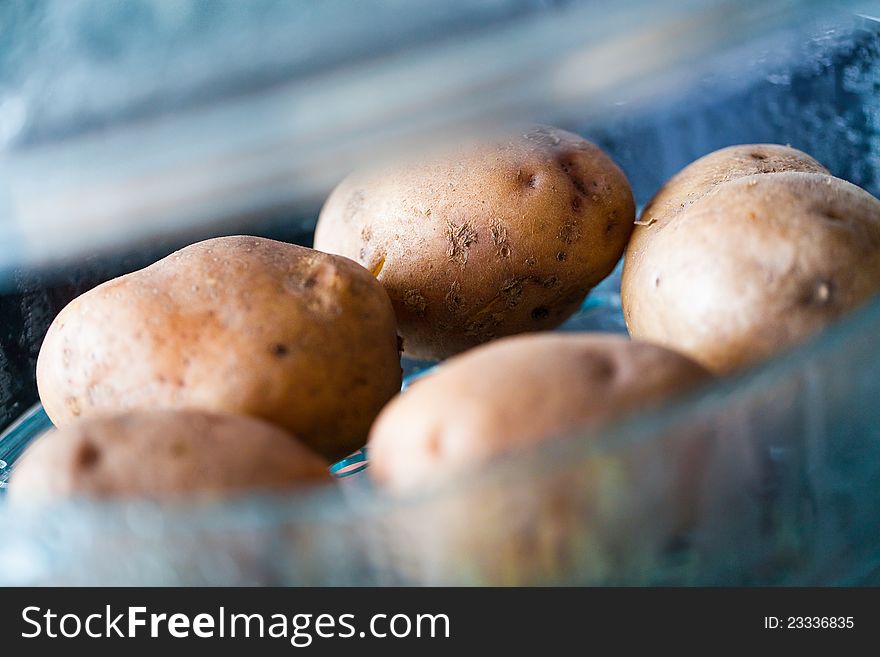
[367,334,709,585]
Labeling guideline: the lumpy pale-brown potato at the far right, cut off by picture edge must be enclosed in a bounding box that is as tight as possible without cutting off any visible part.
[621,146,880,374]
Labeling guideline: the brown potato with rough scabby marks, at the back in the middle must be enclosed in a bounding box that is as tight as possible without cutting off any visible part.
[315,127,635,358]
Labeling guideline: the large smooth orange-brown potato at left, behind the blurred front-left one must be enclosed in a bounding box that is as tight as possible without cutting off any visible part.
[37,236,401,459]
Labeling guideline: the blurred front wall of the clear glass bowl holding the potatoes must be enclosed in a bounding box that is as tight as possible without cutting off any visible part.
[0,262,880,585]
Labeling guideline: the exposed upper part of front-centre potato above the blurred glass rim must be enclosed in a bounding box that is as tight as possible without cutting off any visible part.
[368,333,709,491]
